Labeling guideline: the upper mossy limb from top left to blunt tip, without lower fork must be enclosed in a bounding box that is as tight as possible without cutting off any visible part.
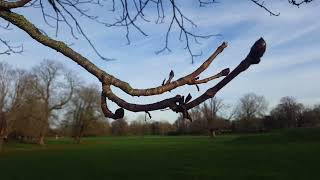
[0,11,227,96]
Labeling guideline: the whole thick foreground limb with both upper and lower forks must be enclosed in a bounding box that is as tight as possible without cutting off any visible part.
[0,11,266,119]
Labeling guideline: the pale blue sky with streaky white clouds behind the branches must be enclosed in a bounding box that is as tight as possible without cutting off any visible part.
[0,0,320,122]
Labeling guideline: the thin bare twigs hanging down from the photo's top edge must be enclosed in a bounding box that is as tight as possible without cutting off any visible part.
[0,0,313,63]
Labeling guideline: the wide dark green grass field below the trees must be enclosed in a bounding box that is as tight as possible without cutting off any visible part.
[0,129,320,180]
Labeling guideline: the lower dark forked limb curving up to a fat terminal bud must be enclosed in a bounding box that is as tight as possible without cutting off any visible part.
[101,38,266,120]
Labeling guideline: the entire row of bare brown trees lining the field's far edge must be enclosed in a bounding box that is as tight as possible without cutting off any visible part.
[0,60,320,148]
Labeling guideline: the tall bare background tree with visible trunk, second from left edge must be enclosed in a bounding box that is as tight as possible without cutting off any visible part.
[32,60,74,145]
